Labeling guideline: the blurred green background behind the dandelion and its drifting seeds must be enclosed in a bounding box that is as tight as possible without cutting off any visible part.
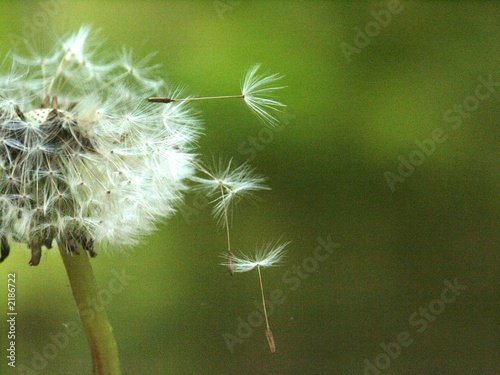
[0,0,500,374]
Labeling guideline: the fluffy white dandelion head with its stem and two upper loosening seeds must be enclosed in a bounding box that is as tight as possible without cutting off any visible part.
[0,26,281,374]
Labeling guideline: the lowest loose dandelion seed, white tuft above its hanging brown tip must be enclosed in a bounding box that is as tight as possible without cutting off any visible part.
[223,242,289,353]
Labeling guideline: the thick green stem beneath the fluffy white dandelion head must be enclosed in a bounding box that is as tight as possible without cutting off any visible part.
[59,243,121,375]
